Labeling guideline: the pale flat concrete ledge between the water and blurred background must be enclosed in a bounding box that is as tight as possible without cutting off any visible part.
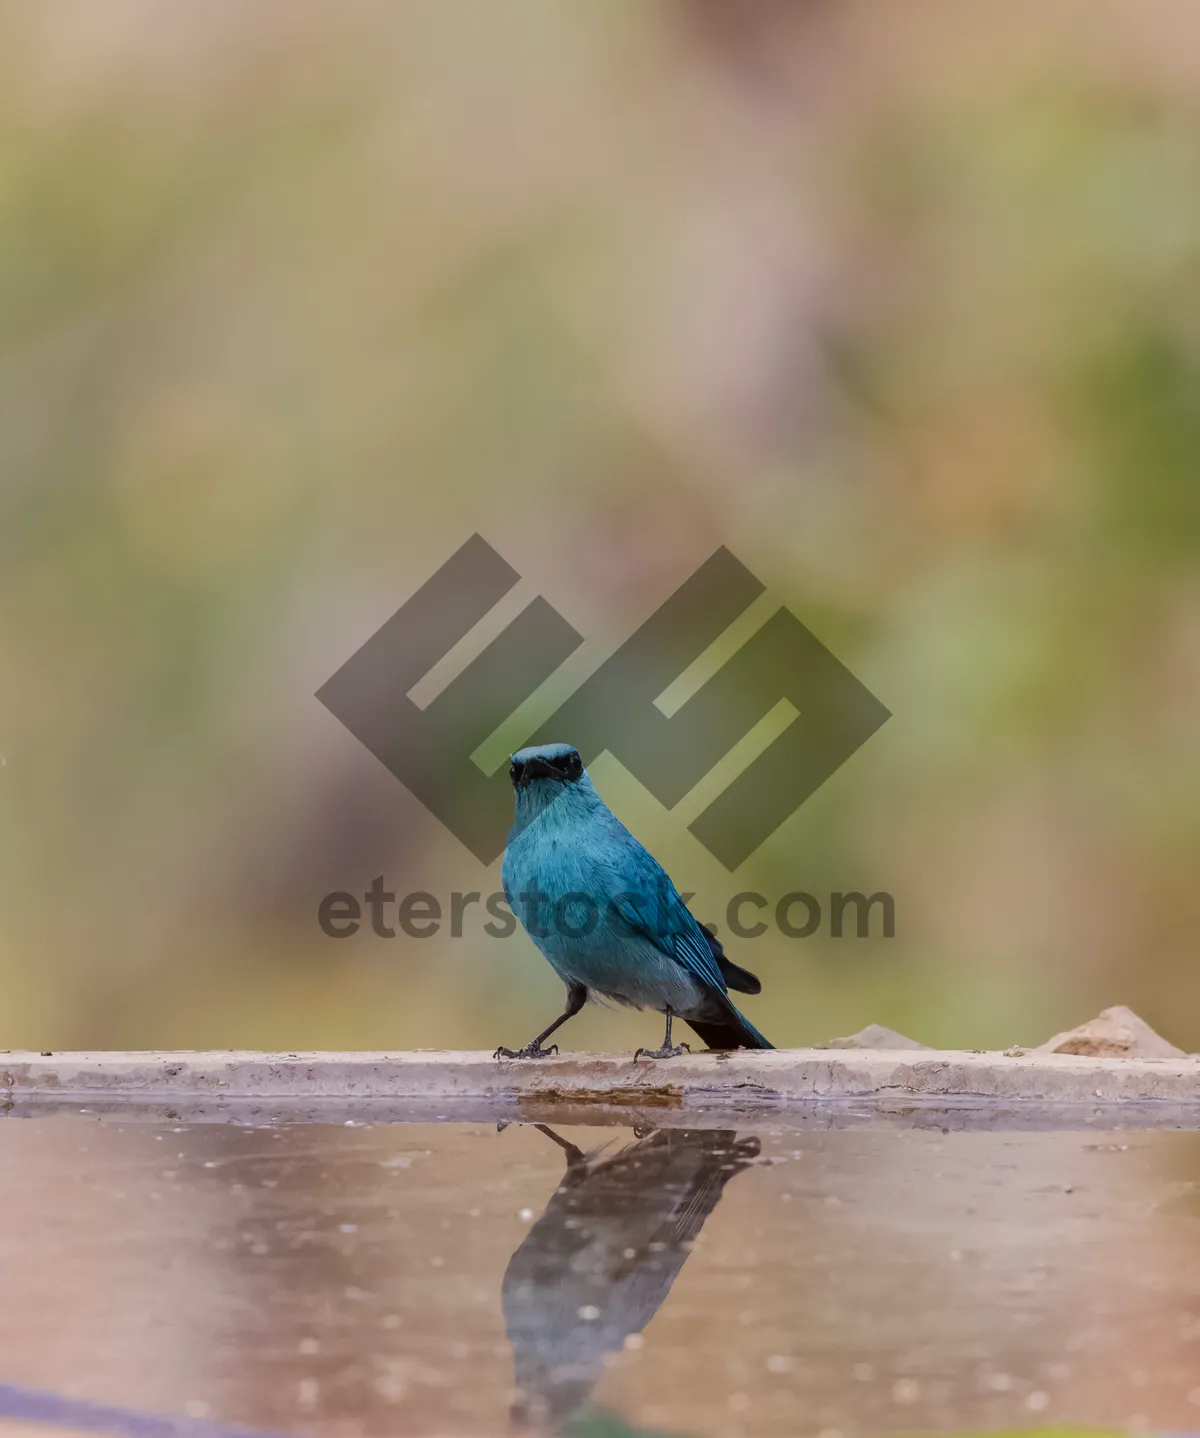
[0,1048,1200,1116]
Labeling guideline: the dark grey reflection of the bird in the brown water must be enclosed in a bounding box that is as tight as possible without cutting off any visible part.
[501,1123,758,1434]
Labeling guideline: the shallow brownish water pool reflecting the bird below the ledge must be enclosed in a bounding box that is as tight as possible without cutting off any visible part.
[0,1113,1200,1438]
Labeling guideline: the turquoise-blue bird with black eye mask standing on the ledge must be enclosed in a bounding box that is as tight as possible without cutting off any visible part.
[496,743,774,1058]
